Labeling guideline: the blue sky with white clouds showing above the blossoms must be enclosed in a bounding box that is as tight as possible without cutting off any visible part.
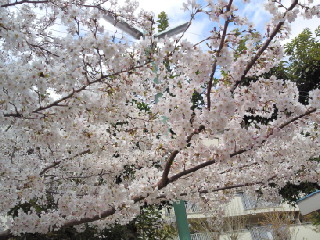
[110,0,320,43]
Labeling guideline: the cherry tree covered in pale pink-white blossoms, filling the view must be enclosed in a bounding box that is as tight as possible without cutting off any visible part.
[0,0,320,239]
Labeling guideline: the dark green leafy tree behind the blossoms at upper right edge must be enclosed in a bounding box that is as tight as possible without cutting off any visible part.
[240,26,320,128]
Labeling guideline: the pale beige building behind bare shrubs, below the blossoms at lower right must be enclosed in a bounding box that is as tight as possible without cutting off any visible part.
[164,193,320,240]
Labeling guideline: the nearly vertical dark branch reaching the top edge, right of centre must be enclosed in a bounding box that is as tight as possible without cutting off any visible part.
[207,0,233,111]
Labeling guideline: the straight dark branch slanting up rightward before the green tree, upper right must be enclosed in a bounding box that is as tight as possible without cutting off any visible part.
[231,0,298,93]
